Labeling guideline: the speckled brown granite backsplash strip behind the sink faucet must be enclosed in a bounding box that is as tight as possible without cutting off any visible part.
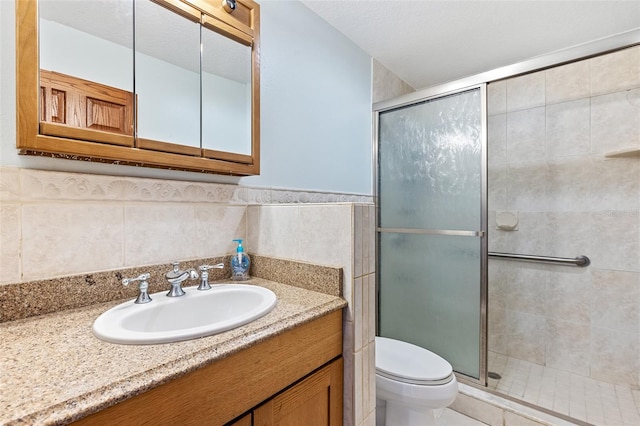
[0,255,342,323]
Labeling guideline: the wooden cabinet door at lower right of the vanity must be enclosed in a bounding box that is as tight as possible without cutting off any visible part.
[253,358,342,426]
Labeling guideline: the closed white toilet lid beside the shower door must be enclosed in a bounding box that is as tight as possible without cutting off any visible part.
[376,337,453,385]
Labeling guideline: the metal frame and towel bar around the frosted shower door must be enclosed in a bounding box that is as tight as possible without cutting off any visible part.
[373,83,488,386]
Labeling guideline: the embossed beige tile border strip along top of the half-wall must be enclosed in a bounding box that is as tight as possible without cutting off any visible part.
[0,167,373,204]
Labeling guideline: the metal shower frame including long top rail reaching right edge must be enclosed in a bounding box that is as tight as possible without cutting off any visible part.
[372,29,640,395]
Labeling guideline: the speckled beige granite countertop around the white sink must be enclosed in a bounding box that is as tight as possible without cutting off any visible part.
[0,278,346,425]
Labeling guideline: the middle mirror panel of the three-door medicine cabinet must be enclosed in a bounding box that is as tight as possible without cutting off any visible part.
[135,0,201,155]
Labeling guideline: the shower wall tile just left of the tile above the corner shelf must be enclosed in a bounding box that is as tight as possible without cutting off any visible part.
[546,98,591,158]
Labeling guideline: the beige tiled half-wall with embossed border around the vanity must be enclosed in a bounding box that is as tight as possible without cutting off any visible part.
[0,167,375,425]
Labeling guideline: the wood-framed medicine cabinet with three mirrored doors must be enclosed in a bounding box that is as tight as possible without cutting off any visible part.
[16,0,260,175]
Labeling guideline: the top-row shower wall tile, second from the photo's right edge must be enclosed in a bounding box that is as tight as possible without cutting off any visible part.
[545,60,591,104]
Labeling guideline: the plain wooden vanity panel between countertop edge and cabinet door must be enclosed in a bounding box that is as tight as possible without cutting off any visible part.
[75,310,342,426]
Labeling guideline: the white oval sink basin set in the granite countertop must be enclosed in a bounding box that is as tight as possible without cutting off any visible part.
[93,284,276,345]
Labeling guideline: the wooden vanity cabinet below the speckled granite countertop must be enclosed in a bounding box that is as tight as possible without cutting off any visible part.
[74,311,343,426]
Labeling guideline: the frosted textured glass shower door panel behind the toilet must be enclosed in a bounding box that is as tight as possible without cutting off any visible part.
[378,87,486,380]
